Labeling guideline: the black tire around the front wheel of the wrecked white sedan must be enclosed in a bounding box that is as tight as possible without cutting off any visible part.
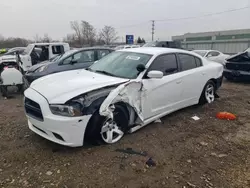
[85,104,129,145]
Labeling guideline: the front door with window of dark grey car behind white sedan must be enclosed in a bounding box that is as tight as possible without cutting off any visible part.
[57,50,96,72]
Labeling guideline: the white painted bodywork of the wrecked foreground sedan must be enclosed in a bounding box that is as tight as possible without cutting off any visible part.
[25,47,223,146]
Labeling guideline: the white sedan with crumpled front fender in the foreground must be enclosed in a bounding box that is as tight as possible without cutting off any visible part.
[25,47,223,147]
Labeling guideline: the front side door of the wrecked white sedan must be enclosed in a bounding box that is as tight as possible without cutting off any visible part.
[142,54,182,119]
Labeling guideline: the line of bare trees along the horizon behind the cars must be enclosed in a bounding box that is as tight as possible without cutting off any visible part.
[0,20,145,48]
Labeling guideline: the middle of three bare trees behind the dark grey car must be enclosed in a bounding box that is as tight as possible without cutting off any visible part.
[81,21,96,46]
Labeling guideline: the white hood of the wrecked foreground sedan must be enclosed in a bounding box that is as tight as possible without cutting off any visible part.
[30,69,129,104]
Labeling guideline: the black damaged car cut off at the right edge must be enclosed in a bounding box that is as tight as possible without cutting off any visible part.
[224,48,250,81]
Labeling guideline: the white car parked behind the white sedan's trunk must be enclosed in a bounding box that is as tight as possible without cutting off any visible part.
[193,50,230,65]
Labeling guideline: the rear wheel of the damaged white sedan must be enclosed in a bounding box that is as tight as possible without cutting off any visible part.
[199,80,216,104]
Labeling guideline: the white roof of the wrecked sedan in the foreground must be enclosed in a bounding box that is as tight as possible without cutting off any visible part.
[118,47,194,55]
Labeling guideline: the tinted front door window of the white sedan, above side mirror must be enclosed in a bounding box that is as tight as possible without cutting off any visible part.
[149,54,178,76]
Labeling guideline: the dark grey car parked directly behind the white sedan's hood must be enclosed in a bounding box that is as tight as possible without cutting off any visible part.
[24,47,114,84]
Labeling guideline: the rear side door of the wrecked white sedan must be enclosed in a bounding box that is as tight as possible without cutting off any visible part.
[178,53,209,107]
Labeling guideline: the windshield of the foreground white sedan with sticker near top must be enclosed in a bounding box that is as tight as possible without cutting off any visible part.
[88,51,152,79]
